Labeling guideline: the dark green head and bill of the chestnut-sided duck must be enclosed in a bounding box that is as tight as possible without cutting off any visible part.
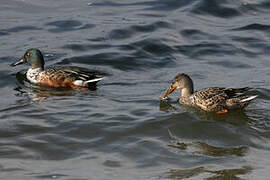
[11,48,44,70]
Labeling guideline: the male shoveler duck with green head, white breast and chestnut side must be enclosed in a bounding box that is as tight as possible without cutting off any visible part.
[11,49,102,89]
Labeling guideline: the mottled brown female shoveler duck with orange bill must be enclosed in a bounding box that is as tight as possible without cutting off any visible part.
[161,74,257,114]
